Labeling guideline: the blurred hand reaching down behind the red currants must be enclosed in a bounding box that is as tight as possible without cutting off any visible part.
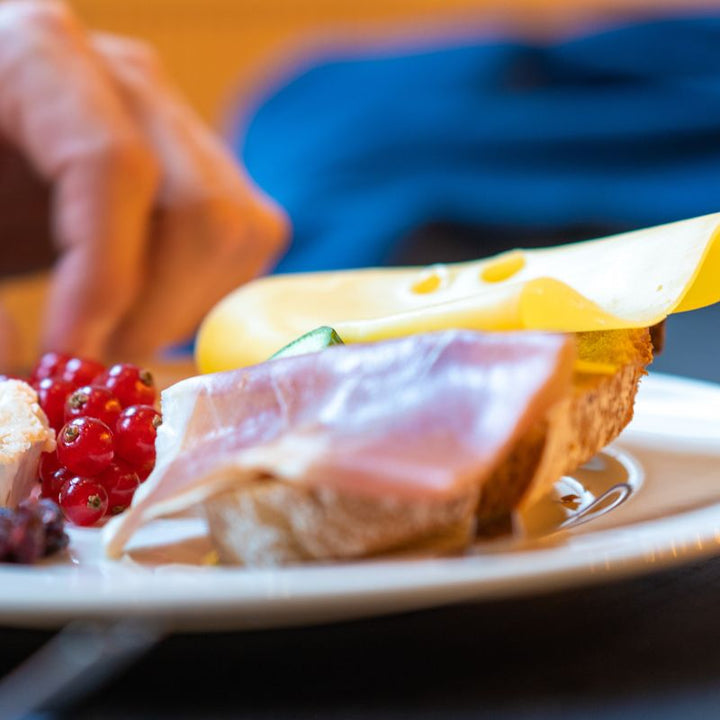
[0,0,287,362]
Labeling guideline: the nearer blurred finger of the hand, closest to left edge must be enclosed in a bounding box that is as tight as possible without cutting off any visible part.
[0,1,157,355]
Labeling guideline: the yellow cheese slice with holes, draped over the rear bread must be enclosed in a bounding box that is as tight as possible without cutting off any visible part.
[197,213,720,372]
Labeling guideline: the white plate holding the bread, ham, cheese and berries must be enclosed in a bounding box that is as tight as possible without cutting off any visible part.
[0,375,720,630]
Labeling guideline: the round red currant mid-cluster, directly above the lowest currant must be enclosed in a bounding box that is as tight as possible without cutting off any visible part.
[57,417,114,476]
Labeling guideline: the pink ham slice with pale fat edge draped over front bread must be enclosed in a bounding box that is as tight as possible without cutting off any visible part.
[105,331,575,556]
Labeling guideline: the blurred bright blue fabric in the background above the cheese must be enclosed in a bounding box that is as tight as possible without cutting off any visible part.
[236,16,720,272]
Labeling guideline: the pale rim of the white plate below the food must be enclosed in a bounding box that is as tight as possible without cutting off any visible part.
[0,373,720,630]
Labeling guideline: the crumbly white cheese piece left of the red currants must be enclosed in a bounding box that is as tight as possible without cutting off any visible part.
[0,380,55,508]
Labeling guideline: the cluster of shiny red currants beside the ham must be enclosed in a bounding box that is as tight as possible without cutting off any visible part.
[30,352,162,525]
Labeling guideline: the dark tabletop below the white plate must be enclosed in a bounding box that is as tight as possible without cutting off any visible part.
[0,560,720,720]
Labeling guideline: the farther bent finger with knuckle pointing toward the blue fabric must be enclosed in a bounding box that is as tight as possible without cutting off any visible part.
[94,36,287,352]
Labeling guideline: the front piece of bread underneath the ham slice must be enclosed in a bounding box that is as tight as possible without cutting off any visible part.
[205,479,477,566]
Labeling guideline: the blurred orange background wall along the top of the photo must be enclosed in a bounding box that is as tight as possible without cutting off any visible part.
[69,0,718,122]
